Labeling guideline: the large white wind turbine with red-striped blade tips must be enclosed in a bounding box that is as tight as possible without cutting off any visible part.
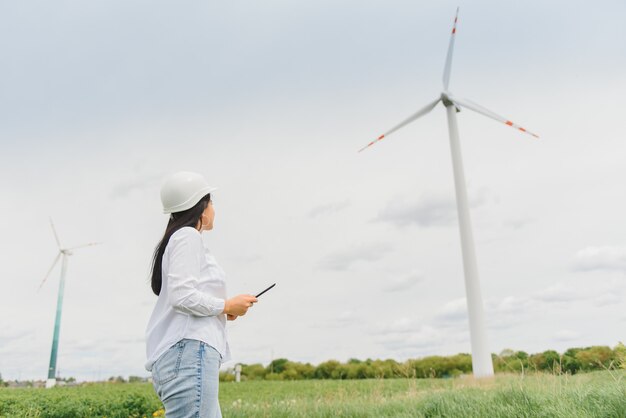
[359,7,538,377]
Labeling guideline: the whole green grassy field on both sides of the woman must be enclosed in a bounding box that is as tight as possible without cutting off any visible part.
[0,371,626,418]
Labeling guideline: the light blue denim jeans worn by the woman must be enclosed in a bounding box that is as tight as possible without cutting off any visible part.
[152,339,222,418]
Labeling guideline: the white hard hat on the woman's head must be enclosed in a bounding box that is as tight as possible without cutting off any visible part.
[161,171,217,213]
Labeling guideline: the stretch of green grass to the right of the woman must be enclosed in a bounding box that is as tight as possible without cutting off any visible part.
[220,372,626,418]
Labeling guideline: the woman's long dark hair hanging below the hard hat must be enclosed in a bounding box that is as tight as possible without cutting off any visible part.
[152,193,211,296]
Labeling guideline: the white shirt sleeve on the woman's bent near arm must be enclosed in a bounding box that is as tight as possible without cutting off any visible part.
[167,228,225,316]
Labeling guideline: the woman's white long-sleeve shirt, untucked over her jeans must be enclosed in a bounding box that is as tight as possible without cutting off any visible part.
[146,227,230,371]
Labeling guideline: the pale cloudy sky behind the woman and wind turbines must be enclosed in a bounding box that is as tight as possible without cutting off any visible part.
[0,0,626,380]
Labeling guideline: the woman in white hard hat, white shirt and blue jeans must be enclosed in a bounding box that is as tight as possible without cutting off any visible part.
[146,172,257,418]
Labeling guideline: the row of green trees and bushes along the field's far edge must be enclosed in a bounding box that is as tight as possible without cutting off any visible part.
[220,343,626,381]
